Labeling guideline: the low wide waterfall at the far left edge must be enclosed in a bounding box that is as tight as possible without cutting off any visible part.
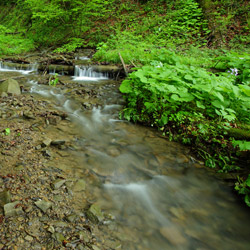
[0,61,37,74]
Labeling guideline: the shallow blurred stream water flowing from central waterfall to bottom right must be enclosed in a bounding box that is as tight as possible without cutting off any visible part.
[1,62,250,250]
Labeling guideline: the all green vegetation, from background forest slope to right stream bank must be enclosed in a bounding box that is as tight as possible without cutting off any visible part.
[0,0,250,206]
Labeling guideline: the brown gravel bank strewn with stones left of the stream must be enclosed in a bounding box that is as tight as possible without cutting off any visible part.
[0,74,122,250]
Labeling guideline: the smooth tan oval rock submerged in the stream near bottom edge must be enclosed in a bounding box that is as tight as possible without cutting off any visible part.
[160,227,187,246]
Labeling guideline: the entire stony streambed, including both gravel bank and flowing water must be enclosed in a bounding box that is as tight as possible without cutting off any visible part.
[0,55,250,250]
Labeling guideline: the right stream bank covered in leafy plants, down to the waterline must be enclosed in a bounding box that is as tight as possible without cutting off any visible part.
[120,50,250,206]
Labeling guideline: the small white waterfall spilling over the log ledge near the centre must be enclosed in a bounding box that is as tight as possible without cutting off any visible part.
[74,66,108,81]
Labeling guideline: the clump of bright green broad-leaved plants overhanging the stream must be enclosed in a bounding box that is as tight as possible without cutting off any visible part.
[120,50,250,172]
